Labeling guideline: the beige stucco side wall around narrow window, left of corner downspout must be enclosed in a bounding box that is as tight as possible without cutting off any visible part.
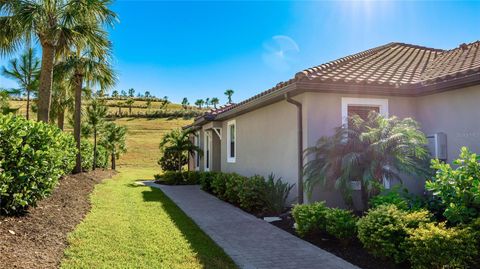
[221,97,297,199]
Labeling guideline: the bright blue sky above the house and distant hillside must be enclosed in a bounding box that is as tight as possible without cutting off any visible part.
[0,0,480,103]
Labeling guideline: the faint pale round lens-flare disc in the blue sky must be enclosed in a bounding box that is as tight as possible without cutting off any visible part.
[262,35,300,72]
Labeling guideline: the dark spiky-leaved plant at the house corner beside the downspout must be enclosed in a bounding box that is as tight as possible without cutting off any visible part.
[264,174,295,215]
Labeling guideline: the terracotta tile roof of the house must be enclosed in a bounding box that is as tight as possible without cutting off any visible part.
[197,41,480,120]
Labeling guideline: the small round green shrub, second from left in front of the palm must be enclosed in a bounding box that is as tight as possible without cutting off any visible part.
[325,208,358,242]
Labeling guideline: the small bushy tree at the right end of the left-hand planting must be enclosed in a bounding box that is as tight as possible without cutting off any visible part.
[100,122,127,170]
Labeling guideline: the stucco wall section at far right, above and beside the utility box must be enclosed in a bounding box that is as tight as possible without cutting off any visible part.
[417,85,480,162]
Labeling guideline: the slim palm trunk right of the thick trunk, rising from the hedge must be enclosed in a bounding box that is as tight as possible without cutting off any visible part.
[73,74,83,173]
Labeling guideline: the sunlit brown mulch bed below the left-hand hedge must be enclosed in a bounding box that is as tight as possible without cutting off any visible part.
[0,170,114,268]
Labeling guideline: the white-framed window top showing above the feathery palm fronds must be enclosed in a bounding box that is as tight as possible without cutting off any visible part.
[342,97,388,124]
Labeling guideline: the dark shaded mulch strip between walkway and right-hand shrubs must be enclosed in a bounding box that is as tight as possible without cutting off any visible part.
[271,214,410,269]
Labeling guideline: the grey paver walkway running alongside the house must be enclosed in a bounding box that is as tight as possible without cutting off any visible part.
[143,181,358,269]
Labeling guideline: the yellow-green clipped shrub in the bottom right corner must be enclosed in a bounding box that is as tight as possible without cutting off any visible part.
[406,223,477,269]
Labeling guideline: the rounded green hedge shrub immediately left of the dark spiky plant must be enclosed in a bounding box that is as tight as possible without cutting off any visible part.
[238,176,266,213]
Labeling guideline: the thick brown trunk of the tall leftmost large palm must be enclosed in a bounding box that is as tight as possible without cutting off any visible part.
[37,42,55,123]
